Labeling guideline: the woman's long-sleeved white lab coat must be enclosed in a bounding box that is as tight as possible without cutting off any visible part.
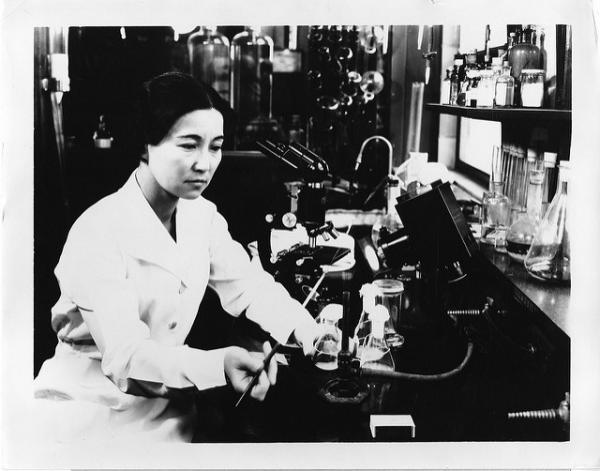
[34,174,314,441]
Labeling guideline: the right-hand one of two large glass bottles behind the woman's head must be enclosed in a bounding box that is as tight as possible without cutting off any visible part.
[231,26,273,123]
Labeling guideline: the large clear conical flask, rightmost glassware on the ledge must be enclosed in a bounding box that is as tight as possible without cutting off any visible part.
[525,162,571,284]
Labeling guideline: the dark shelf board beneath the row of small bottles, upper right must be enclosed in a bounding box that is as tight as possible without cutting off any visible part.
[425,103,571,122]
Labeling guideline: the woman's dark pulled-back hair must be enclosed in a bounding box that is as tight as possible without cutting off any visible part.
[139,72,232,158]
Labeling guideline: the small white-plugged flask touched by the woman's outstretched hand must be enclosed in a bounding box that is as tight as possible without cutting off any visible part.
[313,304,343,371]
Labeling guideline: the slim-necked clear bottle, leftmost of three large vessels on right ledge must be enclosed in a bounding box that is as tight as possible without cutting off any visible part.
[479,146,511,251]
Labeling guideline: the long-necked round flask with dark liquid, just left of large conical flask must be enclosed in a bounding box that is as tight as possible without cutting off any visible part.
[506,158,544,262]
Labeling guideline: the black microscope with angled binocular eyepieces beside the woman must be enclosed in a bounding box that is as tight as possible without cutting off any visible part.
[257,140,354,306]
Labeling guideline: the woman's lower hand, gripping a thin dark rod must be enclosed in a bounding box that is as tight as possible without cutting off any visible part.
[224,342,277,401]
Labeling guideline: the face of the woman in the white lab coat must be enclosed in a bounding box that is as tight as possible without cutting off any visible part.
[148,109,223,199]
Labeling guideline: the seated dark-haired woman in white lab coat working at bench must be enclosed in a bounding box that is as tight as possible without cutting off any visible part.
[35,73,316,441]
